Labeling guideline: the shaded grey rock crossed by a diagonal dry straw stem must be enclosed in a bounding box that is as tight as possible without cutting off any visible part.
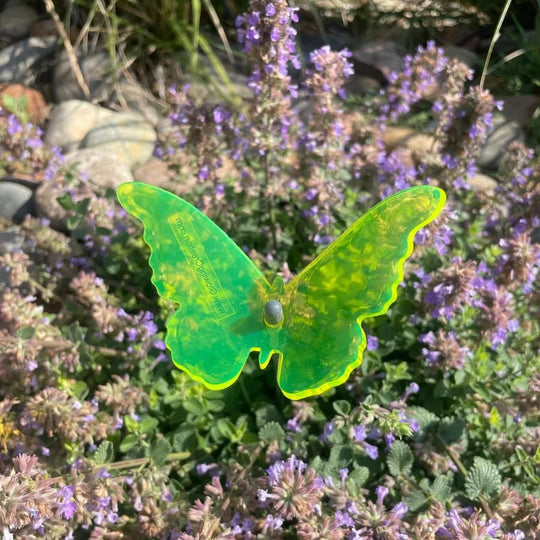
[53,50,113,101]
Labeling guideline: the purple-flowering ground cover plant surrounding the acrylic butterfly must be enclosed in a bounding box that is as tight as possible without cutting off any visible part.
[0,0,540,540]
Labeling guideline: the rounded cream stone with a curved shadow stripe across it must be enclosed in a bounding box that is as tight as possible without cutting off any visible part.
[81,113,157,169]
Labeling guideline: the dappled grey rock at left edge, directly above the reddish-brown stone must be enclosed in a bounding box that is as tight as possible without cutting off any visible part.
[0,36,56,86]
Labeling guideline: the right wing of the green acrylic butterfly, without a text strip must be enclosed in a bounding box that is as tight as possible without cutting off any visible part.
[274,186,446,399]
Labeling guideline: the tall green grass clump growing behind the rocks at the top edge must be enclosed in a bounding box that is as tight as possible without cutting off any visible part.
[66,0,233,94]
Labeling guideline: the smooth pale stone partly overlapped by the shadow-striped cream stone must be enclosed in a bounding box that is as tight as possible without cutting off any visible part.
[45,99,114,152]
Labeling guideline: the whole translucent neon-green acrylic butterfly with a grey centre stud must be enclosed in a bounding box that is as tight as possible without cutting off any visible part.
[118,182,446,399]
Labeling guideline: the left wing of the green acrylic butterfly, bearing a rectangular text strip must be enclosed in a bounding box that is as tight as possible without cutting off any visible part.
[117,182,270,390]
